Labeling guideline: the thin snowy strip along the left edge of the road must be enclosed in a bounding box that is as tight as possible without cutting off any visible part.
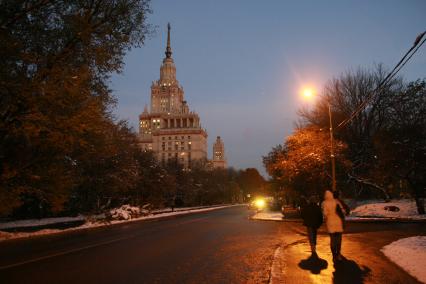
[0,204,241,241]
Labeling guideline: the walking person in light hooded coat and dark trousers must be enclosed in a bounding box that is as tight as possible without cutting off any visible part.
[322,190,345,261]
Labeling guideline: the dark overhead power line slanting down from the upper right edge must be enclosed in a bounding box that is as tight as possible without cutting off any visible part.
[336,31,426,129]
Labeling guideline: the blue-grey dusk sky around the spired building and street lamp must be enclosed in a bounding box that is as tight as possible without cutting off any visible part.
[111,0,426,177]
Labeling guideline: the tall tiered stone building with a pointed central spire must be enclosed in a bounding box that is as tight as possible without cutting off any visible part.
[139,24,207,168]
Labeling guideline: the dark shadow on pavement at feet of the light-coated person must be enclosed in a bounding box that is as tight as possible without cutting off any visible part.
[333,257,371,284]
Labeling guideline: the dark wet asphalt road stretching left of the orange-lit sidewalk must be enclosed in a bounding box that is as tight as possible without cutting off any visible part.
[0,207,281,283]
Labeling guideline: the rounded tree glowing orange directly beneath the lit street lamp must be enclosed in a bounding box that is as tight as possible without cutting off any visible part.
[264,126,350,200]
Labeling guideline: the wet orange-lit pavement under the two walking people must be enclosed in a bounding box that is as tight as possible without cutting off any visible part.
[271,223,426,283]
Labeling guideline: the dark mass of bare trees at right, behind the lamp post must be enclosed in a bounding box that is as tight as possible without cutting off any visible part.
[292,65,426,212]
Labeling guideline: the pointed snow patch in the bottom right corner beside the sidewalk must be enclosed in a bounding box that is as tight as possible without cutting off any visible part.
[382,236,426,283]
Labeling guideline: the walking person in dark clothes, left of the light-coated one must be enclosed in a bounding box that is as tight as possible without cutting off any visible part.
[300,196,323,257]
